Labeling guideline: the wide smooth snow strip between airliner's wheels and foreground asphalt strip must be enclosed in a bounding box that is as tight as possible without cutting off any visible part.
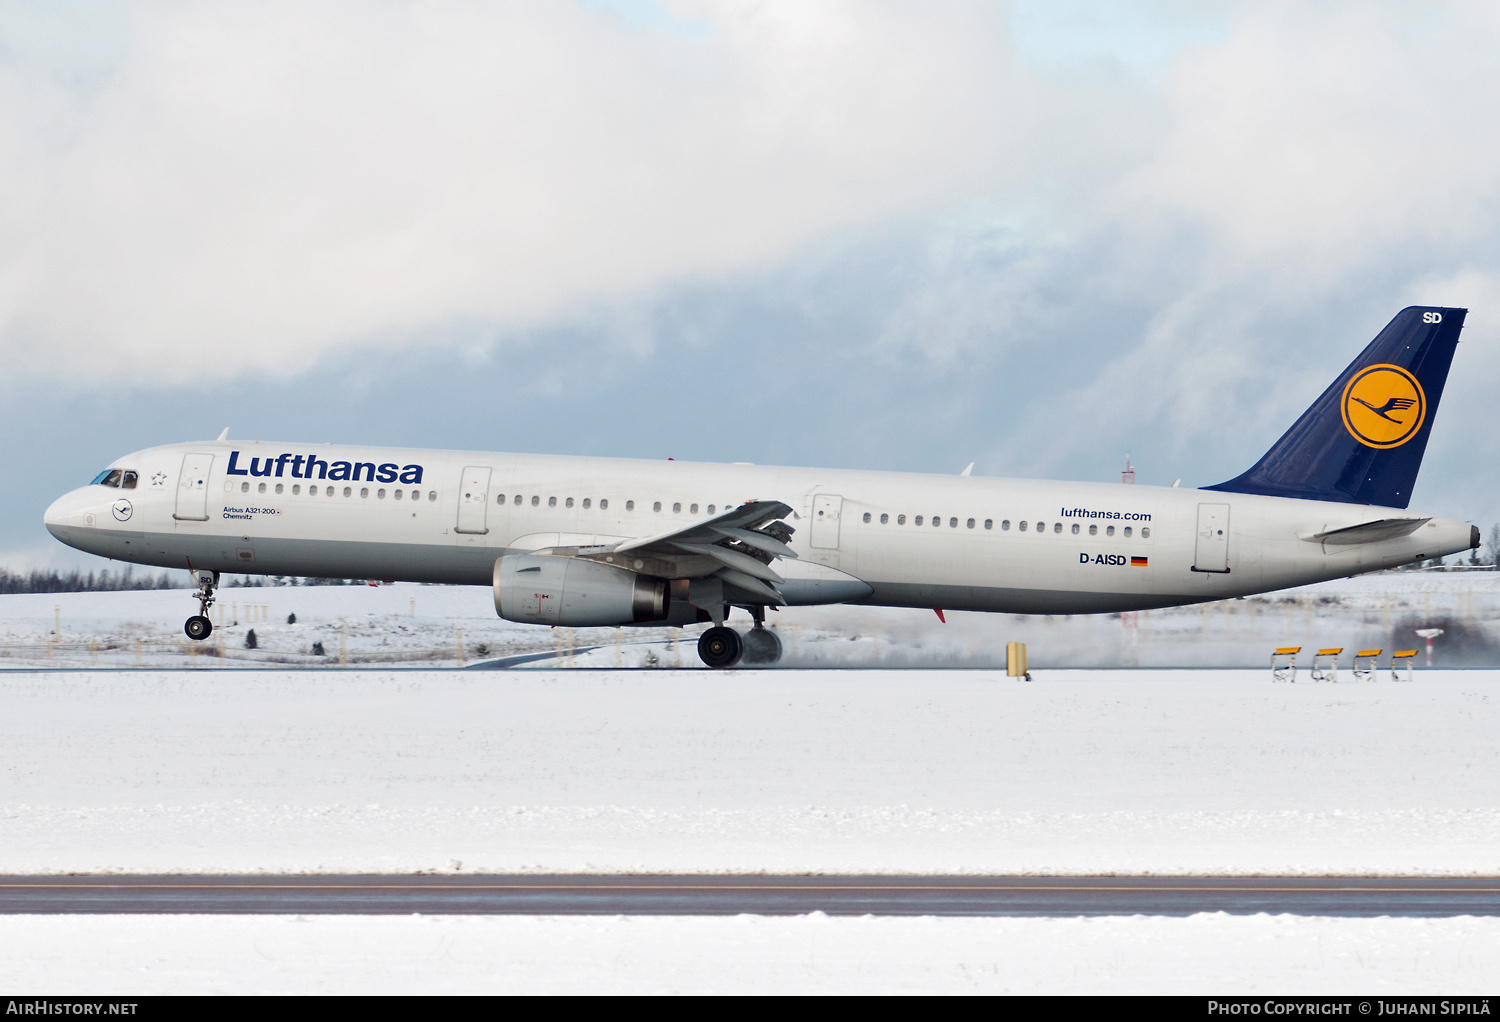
[0,669,1500,873]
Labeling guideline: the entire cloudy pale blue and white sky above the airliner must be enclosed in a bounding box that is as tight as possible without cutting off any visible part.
[0,0,1500,567]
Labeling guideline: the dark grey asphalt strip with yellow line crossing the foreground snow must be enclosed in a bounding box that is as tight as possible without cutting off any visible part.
[0,875,1500,917]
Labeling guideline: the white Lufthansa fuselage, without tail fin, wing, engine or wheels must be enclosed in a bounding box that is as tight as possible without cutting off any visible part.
[47,441,1473,614]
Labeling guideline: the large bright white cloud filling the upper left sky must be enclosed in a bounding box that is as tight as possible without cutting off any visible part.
[0,0,1037,383]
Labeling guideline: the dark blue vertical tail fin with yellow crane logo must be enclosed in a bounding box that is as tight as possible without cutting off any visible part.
[1205,306,1469,507]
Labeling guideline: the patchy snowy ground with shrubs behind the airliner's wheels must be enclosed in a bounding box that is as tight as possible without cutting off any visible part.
[0,572,1500,669]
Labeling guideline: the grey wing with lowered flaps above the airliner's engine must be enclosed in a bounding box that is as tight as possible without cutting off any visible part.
[537,500,797,606]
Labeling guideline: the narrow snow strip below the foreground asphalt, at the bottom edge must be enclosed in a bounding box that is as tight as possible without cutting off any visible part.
[11,914,1500,990]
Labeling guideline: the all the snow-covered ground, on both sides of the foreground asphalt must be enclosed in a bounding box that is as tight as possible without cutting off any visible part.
[0,573,1500,995]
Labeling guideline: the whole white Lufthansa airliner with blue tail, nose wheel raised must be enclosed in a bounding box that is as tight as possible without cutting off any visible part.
[47,308,1479,668]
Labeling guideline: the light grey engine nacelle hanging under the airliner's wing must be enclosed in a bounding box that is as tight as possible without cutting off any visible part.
[495,554,671,627]
